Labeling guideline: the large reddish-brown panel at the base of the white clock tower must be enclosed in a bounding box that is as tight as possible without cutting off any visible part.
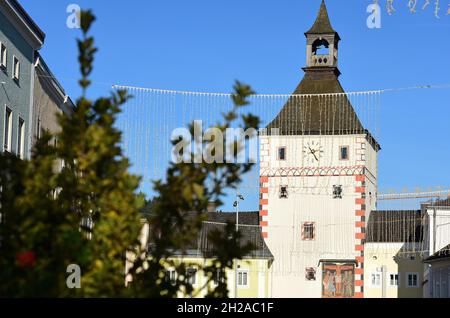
[322,263,355,298]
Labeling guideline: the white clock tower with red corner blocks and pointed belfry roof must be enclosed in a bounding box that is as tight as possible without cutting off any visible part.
[260,2,380,298]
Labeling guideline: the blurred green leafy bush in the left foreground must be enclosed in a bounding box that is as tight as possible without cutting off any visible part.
[0,11,259,297]
